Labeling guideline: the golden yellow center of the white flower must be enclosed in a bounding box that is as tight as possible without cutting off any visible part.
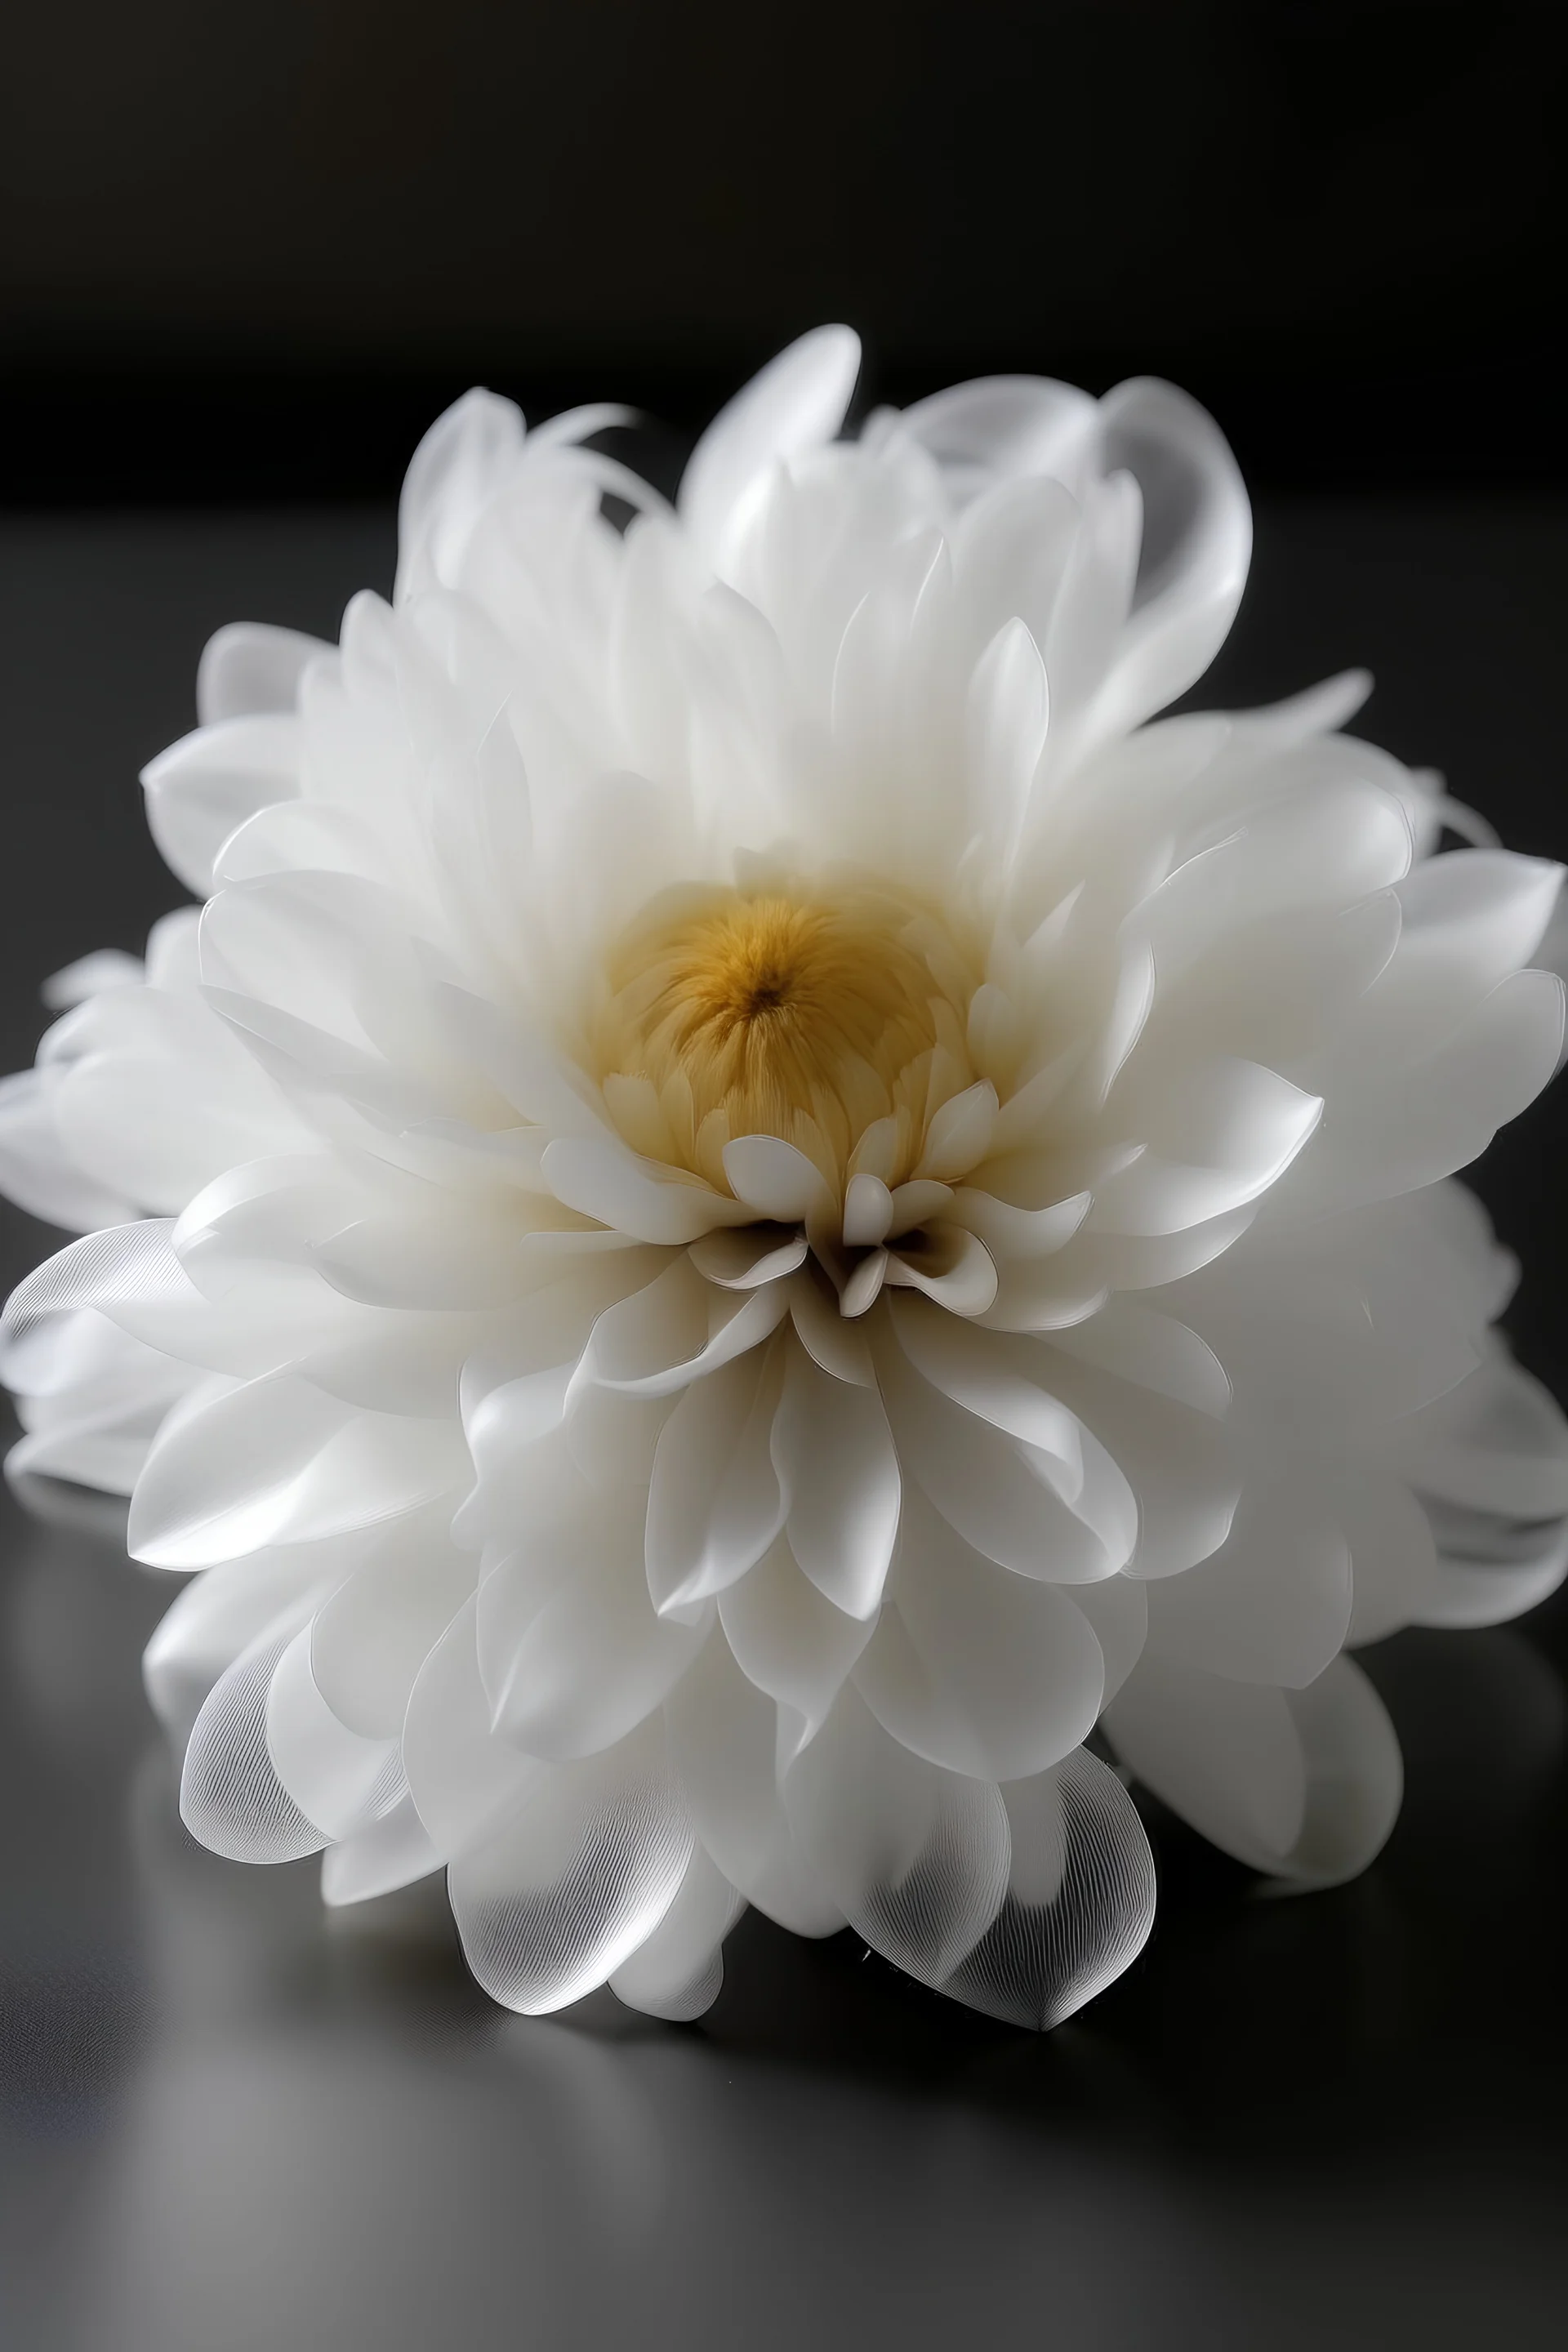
[597,889,976,1186]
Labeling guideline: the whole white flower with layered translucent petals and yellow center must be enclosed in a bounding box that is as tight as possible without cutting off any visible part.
[0,329,1568,2025]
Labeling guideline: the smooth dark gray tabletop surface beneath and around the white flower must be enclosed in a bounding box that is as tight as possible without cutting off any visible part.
[0,499,1568,2352]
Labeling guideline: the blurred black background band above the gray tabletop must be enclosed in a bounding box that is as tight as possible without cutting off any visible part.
[0,0,1566,503]
